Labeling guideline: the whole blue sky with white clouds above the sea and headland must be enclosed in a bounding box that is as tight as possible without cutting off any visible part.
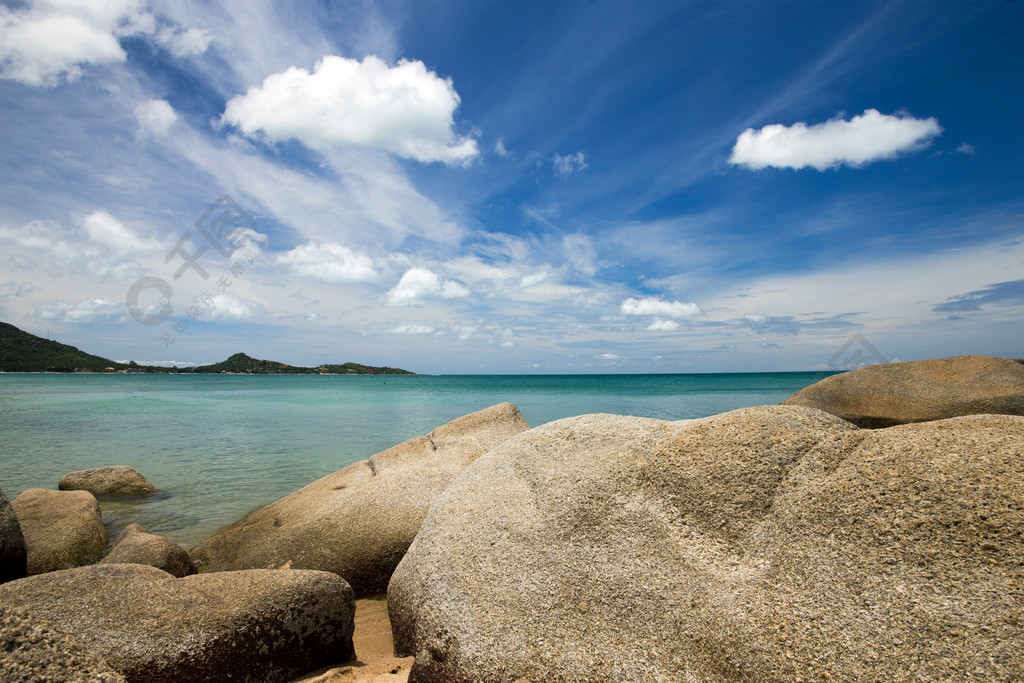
[0,0,1024,373]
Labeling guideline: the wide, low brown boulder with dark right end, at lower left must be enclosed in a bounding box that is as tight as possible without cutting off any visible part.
[0,564,355,683]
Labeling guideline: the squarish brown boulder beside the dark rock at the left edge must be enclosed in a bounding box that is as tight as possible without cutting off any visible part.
[12,488,106,575]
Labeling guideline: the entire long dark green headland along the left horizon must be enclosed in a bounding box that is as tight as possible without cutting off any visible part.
[0,323,416,375]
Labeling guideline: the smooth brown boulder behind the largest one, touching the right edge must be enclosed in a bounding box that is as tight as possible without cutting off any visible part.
[782,355,1024,429]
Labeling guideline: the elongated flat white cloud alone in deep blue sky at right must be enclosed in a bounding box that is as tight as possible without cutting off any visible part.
[729,109,942,171]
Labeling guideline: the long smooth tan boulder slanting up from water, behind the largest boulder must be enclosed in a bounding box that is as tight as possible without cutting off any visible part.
[191,403,528,596]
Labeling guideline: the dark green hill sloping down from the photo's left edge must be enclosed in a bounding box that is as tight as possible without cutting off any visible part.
[0,323,127,373]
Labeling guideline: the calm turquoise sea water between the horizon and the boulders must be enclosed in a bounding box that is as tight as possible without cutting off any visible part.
[0,373,830,548]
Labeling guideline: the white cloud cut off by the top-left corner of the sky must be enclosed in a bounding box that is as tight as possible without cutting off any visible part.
[0,0,156,87]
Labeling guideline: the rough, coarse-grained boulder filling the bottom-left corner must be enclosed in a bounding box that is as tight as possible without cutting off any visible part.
[0,606,125,683]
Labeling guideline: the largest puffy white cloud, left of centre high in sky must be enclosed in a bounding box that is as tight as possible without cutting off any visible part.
[221,54,478,164]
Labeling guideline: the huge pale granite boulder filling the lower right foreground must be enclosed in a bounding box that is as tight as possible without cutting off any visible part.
[388,407,1024,682]
